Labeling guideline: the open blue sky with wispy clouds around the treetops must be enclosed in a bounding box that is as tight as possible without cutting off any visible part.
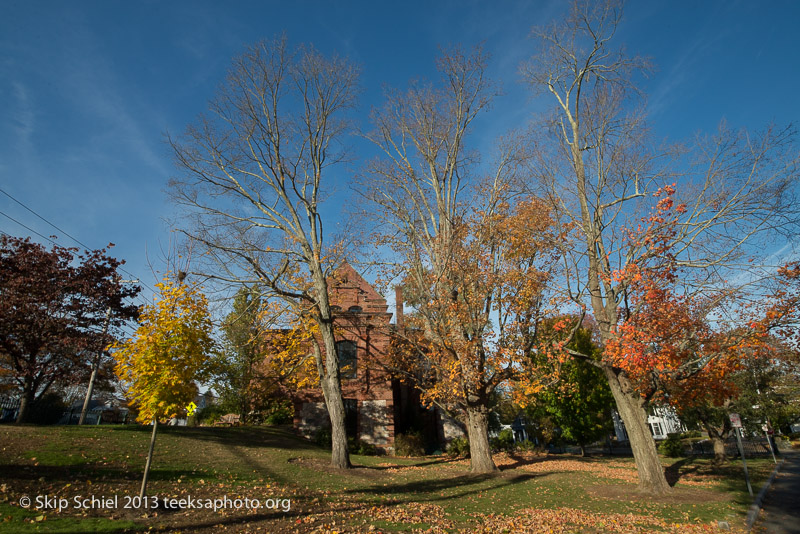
[0,0,800,312]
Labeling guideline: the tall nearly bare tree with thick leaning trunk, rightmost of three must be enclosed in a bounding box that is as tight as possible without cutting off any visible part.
[523,1,798,494]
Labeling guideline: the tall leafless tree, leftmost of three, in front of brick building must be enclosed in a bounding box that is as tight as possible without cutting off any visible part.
[170,39,358,468]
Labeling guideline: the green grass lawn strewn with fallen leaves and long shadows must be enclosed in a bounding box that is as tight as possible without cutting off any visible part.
[0,426,773,534]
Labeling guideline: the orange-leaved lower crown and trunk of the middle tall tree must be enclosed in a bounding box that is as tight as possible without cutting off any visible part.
[384,191,556,472]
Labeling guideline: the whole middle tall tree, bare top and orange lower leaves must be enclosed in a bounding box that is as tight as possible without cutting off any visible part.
[363,50,555,473]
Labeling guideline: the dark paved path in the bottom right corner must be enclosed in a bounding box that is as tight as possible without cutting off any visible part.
[752,451,800,534]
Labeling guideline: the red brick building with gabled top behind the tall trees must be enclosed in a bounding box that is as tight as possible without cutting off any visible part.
[292,263,460,451]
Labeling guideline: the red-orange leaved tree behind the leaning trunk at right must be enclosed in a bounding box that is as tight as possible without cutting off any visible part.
[604,186,797,463]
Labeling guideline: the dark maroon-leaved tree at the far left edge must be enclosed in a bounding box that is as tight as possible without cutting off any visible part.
[0,235,139,423]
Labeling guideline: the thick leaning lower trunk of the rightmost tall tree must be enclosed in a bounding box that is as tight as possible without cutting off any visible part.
[604,367,672,495]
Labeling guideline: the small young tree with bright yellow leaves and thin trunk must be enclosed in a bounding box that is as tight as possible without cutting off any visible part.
[113,278,214,498]
